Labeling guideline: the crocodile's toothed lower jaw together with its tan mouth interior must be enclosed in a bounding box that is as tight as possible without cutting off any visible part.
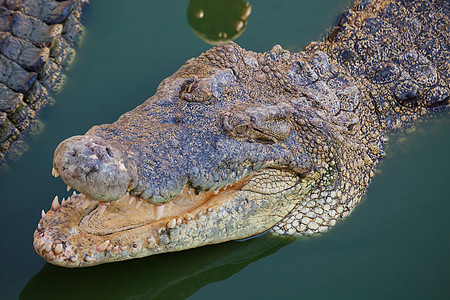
[34,169,300,267]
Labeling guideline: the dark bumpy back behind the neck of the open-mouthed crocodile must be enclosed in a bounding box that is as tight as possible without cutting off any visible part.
[318,0,450,128]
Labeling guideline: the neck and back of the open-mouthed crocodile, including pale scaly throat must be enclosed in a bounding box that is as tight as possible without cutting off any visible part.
[273,0,450,235]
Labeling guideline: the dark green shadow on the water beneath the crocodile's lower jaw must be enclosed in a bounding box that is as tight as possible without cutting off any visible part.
[19,234,295,299]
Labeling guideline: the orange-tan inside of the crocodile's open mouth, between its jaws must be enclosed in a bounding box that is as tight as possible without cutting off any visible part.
[73,173,247,236]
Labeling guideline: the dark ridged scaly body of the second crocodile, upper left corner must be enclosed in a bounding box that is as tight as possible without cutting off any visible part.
[0,0,87,167]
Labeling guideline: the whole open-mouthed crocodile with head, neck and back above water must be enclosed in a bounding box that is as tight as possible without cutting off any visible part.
[33,0,450,267]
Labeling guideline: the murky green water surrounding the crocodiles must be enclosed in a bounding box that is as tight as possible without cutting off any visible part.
[0,0,450,299]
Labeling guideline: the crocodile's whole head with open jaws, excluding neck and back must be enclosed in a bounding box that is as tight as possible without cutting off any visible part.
[34,43,334,267]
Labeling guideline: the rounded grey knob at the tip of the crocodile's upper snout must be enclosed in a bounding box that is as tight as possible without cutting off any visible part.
[53,135,136,202]
